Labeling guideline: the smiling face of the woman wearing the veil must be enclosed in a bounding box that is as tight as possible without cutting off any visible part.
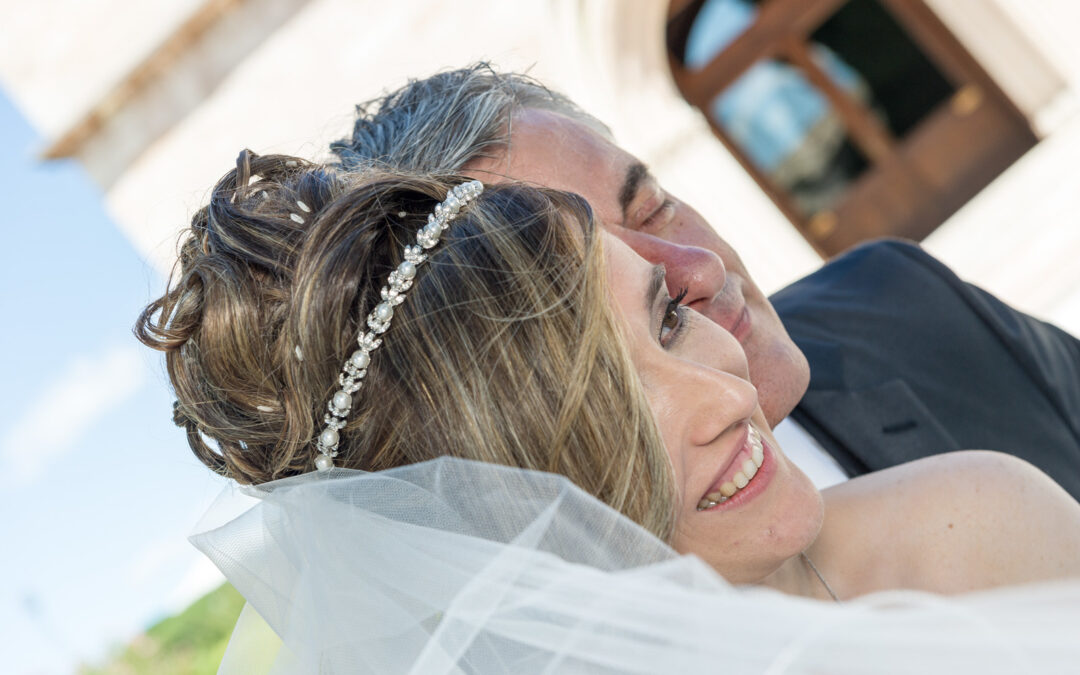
[604,234,823,583]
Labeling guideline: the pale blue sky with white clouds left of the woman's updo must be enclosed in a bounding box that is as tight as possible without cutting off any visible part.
[0,92,230,674]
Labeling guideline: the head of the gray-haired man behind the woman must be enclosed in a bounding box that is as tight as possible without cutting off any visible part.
[330,64,809,424]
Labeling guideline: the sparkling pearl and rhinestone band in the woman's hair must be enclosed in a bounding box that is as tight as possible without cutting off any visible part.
[315,180,484,471]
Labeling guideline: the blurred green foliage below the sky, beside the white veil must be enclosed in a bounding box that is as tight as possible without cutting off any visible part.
[80,583,244,675]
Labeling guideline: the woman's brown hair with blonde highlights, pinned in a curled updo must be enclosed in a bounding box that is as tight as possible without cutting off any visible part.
[135,151,675,539]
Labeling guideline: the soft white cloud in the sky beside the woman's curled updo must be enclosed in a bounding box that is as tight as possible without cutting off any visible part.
[0,345,146,483]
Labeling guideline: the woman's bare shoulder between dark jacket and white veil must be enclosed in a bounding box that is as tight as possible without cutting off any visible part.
[825,450,1080,593]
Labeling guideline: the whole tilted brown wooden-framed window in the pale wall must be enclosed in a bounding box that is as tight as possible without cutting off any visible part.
[667,0,1036,256]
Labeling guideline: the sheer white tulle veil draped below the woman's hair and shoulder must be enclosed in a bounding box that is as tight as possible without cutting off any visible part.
[191,458,1080,675]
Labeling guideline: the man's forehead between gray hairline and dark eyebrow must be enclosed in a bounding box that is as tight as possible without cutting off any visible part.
[464,108,648,225]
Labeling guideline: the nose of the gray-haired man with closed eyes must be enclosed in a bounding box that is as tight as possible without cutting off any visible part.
[611,228,728,309]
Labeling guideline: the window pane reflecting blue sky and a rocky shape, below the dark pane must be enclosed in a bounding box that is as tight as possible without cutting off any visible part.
[708,59,867,217]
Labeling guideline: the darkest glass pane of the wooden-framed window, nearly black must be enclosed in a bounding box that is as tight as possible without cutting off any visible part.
[810,0,954,138]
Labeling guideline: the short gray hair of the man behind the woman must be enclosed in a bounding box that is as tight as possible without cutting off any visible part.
[330,63,610,173]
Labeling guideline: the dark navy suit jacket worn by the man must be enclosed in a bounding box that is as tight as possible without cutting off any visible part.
[771,240,1080,499]
